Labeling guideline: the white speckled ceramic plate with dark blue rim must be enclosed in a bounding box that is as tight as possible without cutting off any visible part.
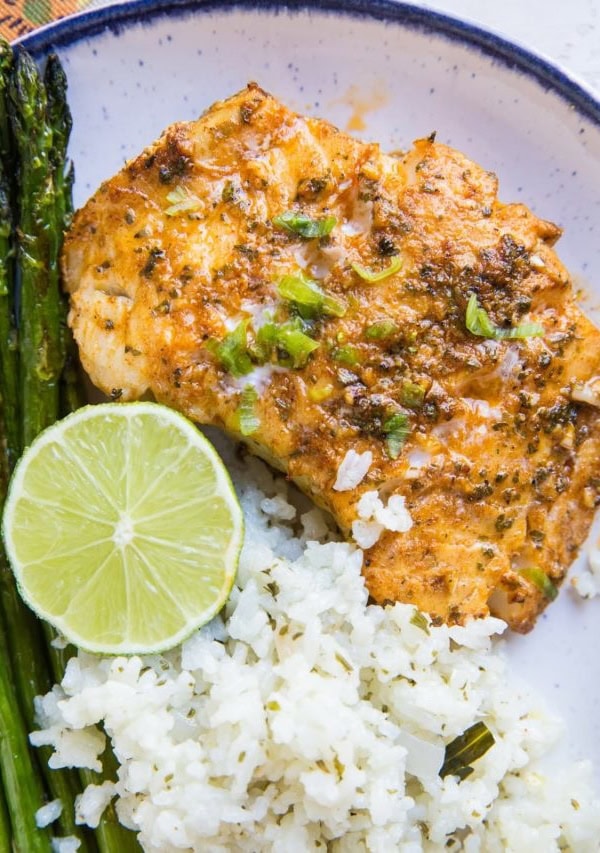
[25,0,600,778]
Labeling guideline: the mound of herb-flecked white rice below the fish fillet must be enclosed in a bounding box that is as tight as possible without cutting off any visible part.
[32,442,600,853]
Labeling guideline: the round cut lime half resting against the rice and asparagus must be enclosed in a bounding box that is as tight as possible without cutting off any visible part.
[3,403,243,654]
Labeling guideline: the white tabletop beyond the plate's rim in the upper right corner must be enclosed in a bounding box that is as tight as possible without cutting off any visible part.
[414,0,600,95]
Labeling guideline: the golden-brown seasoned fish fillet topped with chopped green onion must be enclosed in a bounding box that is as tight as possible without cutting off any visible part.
[62,85,600,631]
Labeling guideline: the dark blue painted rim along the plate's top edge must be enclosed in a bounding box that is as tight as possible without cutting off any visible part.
[15,0,600,126]
